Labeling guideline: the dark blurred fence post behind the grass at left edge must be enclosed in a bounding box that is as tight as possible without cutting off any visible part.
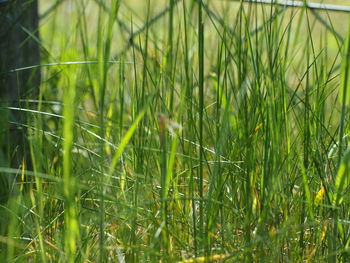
[0,0,40,167]
